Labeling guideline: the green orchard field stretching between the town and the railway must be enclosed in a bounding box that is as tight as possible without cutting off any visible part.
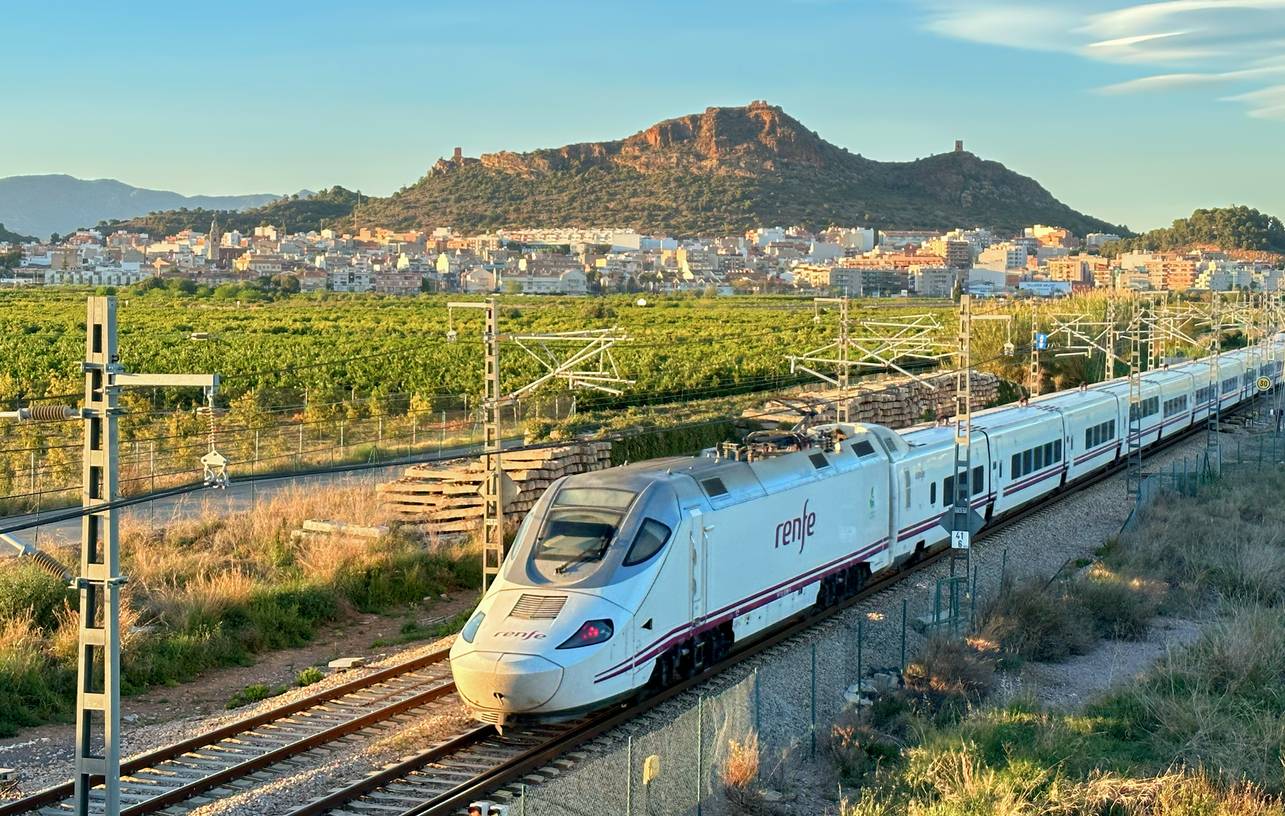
[0,288,950,511]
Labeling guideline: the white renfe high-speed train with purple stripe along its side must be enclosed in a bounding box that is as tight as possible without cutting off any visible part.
[451,335,1285,726]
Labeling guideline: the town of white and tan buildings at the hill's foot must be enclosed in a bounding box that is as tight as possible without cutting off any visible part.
[0,221,1282,298]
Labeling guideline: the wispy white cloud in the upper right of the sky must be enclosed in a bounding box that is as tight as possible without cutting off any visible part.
[924,0,1285,118]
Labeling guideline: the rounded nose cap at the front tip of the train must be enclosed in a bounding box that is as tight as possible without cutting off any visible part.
[451,652,563,712]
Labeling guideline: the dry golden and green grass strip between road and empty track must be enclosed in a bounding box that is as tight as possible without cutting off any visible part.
[0,486,479,734]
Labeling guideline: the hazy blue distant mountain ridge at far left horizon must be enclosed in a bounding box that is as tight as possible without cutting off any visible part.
[0,175,280,238]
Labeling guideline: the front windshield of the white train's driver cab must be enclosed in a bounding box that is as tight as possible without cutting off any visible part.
[535,487,635,574]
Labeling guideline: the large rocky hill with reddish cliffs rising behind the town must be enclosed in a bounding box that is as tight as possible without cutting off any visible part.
[341,102,1122,235]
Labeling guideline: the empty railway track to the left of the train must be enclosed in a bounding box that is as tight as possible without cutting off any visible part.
[0,649,455,816]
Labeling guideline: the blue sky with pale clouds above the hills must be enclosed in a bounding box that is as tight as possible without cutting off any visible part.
[0,0,1285,229]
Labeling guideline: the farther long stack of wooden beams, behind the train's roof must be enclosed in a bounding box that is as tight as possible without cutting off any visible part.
[745,371,1000,428]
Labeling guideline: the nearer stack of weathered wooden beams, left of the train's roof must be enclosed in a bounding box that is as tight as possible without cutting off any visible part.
[378,442,612,533]
